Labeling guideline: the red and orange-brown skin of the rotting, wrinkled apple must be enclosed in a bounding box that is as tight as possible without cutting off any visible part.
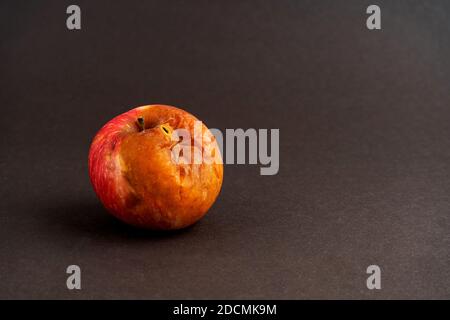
[88,105,223,230]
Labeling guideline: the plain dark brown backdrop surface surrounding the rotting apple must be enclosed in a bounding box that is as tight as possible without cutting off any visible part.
[0,0,450,299]
